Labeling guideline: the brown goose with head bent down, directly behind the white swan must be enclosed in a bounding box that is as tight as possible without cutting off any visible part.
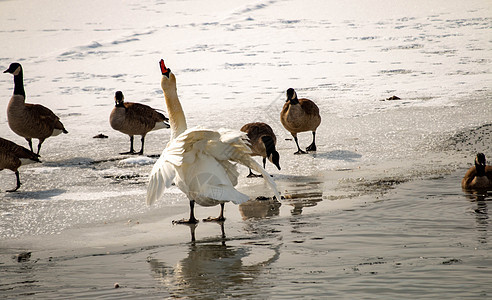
[241,122,280,177]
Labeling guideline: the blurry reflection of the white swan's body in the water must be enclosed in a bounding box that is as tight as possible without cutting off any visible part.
[147,237,280,299]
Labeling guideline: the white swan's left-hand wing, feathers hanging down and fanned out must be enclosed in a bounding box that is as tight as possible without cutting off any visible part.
[147,148,182,205]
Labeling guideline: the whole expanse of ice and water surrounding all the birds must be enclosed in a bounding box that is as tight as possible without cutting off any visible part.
[0,0,492,299]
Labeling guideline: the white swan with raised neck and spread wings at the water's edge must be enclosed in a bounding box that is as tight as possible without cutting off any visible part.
[147,60,280,224]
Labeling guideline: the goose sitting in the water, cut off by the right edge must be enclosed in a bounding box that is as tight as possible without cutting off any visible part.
[461,153,492,190]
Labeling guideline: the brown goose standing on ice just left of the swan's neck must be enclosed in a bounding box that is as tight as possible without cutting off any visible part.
[109,91,170,155]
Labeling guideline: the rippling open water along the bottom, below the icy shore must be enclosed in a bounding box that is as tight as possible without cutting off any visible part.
[0,170,492,299]
